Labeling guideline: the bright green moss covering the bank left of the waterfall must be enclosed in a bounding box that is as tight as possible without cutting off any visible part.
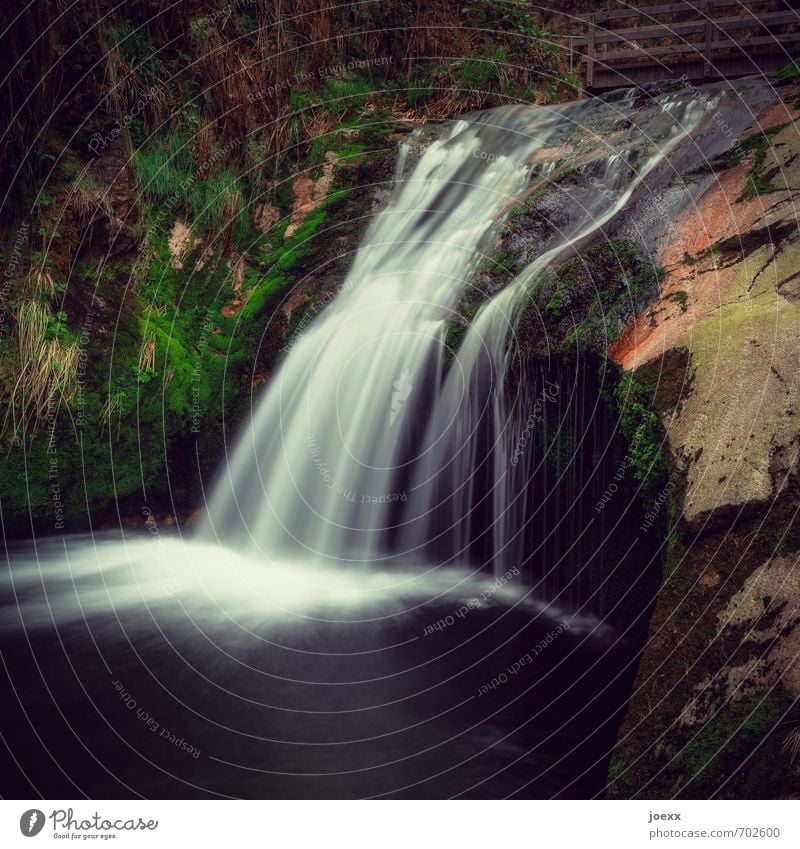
[0,146,358,533]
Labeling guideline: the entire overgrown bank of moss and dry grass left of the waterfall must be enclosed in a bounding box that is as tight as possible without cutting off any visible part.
[0,0,576,532]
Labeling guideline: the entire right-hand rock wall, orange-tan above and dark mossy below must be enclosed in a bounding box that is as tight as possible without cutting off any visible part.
[608,86,800,798]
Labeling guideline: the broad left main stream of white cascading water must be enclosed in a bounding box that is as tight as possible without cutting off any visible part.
[206,107,558,561]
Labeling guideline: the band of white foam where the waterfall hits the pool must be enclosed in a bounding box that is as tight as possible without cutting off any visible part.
[0,533,604,634]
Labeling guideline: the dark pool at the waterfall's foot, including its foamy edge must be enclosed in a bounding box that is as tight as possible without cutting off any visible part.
[0,539,632,798]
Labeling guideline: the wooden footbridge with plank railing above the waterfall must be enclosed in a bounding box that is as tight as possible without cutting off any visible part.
[571,0,800,90]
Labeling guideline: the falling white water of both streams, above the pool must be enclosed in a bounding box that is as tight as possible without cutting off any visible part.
[201,81,770,573]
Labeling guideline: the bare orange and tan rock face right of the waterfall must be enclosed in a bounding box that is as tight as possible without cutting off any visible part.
[611,99,800,529]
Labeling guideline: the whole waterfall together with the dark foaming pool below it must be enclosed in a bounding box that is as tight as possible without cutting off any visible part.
[0,79,788,799]
